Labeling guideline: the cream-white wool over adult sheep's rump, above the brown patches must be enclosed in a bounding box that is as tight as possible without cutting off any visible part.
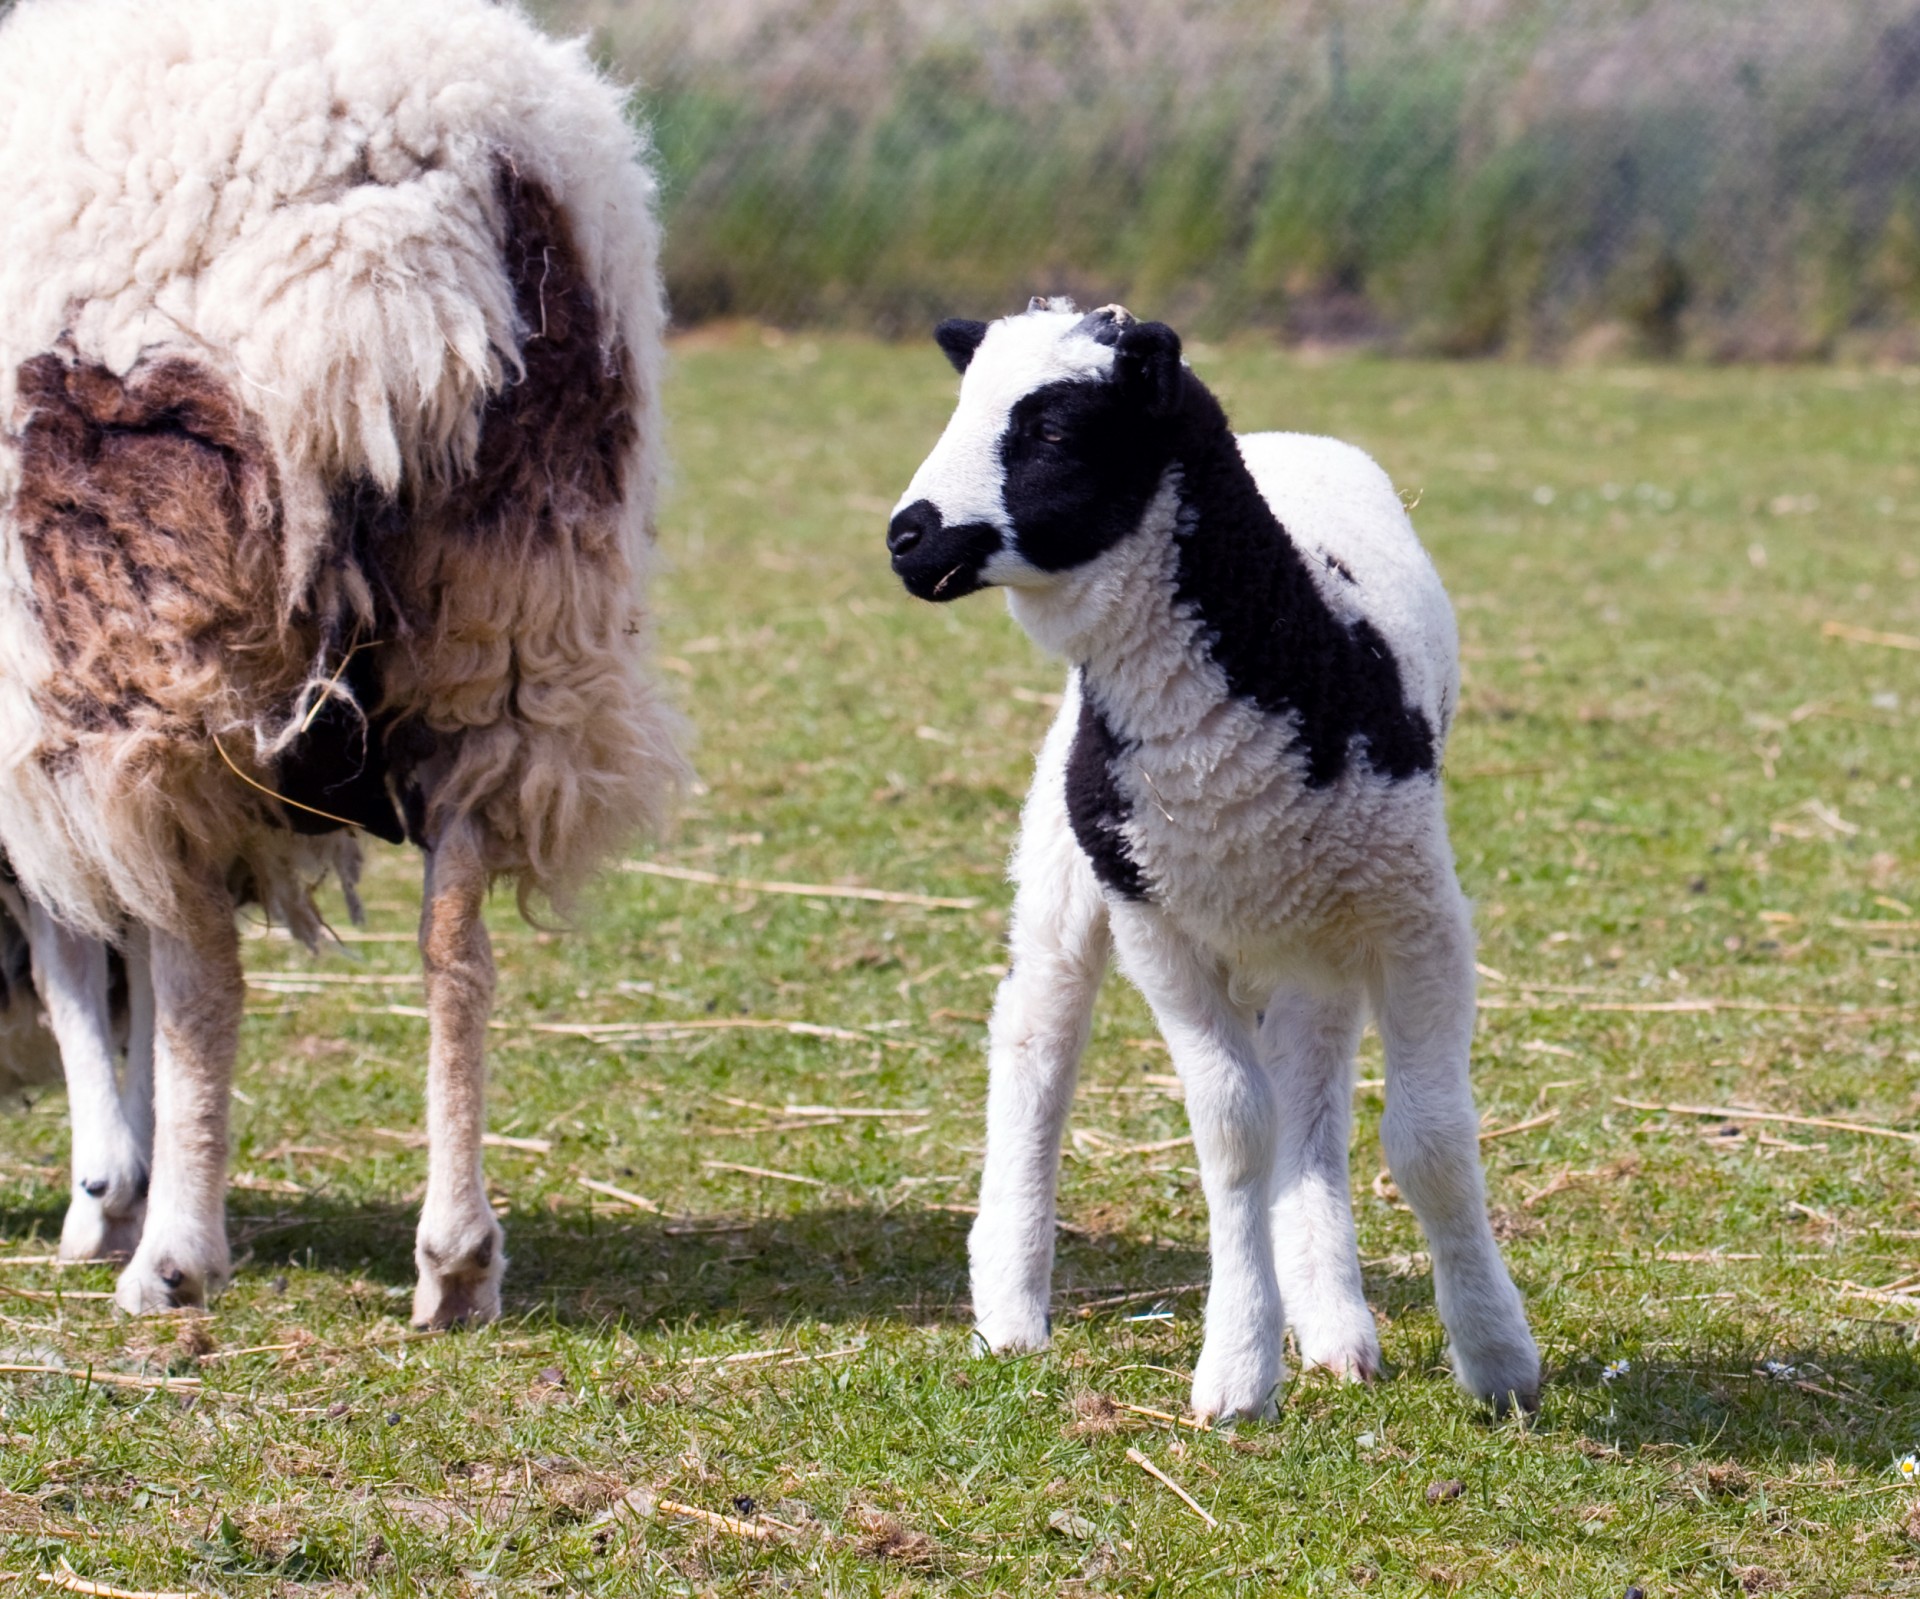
[0,0,662,509]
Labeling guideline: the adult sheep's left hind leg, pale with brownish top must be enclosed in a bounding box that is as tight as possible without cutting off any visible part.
[113,885,246,1315]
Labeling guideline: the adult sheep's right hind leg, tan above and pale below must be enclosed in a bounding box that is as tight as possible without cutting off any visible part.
[413,822,507,1326]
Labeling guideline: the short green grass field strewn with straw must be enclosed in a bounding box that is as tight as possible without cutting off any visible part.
[0,332,1920,1599]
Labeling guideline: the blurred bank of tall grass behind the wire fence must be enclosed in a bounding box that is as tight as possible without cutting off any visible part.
[541,0,1920,359]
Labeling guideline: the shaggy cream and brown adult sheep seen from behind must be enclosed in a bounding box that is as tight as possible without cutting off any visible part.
[0,0,684,1325]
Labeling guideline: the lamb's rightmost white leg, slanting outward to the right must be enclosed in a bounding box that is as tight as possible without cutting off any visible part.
[1377,898,1540,1409]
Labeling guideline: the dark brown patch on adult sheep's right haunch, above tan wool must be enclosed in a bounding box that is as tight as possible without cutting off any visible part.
[445,161,634,549]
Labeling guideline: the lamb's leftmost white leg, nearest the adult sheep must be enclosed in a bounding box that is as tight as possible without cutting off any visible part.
[968,787,1110,1351]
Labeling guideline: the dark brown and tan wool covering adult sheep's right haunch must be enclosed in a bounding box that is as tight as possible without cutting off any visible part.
[357,161,678,898]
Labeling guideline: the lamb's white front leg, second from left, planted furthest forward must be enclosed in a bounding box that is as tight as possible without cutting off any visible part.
[1114,904,1286,1419]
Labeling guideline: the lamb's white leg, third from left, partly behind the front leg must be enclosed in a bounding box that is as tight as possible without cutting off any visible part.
[1260,989,1380,1382]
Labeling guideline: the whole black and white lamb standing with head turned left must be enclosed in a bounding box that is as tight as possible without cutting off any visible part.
[887,299,1540,1419]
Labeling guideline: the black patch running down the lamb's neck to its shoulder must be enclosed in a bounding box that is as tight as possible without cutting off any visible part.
[1173,372,1434,787]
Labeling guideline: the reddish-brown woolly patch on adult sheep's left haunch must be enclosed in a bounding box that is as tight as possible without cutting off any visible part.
[13,353,301,740]
